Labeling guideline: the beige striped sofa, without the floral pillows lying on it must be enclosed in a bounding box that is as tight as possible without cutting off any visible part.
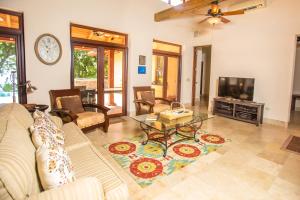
[0,104,128,200]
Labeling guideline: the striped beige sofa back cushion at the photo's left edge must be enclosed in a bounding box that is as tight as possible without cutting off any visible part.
[0,115,41,199]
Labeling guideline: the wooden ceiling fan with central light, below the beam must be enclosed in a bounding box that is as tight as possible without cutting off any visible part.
[199,0,245,25]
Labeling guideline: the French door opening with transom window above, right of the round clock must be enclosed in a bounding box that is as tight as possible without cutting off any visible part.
[71,24,127,117]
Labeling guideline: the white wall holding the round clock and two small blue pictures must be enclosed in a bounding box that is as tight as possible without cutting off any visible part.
[0,0,192,111]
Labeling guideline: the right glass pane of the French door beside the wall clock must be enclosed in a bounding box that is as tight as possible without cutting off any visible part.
[104,49,124,115]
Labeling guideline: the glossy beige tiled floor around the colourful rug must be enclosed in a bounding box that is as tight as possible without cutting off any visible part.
[88,108,300,200]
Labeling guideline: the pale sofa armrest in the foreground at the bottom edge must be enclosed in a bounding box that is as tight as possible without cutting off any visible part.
[28,177,104,200]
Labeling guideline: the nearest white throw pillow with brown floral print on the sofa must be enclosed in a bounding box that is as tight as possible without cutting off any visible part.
[36,145,75,190]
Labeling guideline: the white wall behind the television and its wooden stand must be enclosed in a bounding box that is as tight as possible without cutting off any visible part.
[193,0,300,122]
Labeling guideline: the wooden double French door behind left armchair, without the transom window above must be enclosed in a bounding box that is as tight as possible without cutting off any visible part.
[71,43,127,117]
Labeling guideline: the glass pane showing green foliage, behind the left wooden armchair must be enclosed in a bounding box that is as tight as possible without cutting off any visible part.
[73,46,98,104]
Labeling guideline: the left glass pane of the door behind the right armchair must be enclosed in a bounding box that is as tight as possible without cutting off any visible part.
[152,55,164,97]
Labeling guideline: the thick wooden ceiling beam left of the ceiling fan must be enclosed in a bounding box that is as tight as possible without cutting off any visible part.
[154,0,226,22]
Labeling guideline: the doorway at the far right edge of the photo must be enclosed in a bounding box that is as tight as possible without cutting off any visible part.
[289,36,300,130]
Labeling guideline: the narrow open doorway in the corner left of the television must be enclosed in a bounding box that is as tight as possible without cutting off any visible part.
[192,46,211,110]
